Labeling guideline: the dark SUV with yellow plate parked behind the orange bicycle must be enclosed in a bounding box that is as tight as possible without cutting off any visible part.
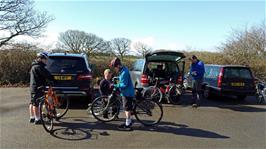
[47,53,92,100]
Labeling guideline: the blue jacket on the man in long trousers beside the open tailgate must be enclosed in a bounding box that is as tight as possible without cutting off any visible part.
[190,61,205,80]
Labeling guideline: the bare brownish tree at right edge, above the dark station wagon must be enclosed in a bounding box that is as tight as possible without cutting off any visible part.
[220,24,266,80]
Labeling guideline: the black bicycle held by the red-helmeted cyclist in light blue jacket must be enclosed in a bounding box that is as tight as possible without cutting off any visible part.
[91,81,163,126]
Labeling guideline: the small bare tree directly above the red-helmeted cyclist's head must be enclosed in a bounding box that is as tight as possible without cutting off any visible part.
[111,38,131,59]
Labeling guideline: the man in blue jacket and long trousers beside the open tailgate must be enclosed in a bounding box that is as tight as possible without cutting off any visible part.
[190,55,205,107]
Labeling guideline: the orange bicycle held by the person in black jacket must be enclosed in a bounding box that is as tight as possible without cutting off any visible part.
[40,86,70,133]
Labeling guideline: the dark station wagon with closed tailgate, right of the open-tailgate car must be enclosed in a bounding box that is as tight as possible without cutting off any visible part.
[203,65,256,100]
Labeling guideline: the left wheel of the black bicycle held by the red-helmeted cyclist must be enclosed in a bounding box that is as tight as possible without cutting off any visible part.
[91,96,120,122]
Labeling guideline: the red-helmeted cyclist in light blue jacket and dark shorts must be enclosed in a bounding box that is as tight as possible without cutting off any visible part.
[110,58,135,131]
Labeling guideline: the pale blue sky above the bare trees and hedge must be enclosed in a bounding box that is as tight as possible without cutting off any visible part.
[18,0,266,51]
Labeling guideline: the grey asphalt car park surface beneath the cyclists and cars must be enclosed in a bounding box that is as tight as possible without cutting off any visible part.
[0,88,266,149]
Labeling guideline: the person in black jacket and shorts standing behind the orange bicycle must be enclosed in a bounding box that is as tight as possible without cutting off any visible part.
[29,52,54,124]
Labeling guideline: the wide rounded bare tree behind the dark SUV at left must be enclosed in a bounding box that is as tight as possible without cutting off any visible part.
[58,30,110,56]
